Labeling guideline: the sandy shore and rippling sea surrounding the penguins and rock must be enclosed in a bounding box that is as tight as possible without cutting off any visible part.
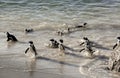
[0,0,120,78]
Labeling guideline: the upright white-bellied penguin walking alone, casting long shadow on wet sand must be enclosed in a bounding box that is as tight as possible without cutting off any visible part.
[25,41,37,58]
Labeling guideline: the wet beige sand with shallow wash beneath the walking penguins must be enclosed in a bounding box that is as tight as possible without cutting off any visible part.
[0,29,120,78]
